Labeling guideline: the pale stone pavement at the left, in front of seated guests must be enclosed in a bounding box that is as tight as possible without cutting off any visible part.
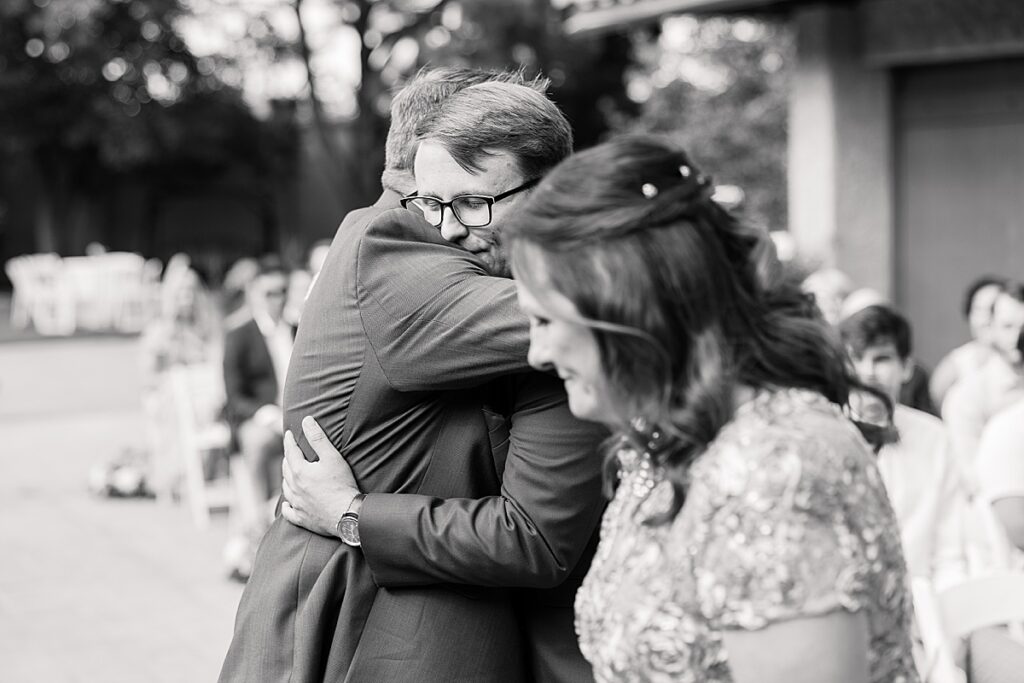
[0,338,242,683]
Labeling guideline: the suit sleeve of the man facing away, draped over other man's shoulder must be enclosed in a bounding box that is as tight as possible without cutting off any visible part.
[356,209,529,391]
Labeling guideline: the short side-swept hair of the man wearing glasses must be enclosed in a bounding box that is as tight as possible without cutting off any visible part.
[416,81,572,179]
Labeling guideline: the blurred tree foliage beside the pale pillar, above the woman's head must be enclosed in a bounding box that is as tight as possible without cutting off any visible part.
[614,17,794,229]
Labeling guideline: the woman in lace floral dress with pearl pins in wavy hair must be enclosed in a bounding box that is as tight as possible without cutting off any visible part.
[503,137,918,683]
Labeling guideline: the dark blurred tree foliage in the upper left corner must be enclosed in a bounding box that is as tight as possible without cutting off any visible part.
[0,0,299,250]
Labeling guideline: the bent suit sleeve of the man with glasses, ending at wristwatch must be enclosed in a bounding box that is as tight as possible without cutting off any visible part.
[359,374,606,588]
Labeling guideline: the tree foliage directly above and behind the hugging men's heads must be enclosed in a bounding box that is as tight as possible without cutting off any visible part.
[280,0,631,201]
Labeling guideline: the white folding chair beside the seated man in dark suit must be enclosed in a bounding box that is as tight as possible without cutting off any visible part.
[165,364,234,528]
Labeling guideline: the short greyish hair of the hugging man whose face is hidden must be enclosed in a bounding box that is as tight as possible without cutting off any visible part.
[384,67,548,177]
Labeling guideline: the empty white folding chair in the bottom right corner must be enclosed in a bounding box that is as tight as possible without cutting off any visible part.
[913,571,1024,683]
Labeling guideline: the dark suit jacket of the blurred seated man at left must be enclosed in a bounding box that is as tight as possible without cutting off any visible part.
[224,318,278,429]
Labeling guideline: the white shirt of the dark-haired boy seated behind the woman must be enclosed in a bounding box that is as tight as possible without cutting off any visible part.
[878,405,967,587]
